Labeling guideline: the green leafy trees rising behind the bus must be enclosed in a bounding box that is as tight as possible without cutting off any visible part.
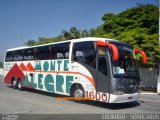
[26,4,160,66]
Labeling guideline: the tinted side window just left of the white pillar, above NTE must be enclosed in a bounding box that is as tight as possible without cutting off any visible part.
[50,42,70,59]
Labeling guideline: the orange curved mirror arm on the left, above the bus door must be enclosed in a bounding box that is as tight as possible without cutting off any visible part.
[97,40,119,61]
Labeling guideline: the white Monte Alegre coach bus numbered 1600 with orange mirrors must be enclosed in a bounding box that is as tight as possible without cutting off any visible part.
[4,37,147,103]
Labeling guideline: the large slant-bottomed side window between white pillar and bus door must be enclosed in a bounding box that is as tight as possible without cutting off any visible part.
[72,41,96,67]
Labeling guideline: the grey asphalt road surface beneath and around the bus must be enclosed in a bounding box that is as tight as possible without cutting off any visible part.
[0,76,160,119]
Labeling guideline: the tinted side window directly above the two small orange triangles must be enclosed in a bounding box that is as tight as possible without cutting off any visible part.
[23,48,34,60]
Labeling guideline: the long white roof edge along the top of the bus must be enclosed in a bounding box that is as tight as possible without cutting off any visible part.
[6,37,123,51]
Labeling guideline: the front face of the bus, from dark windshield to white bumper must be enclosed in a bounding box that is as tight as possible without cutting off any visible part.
[107,42,140,102]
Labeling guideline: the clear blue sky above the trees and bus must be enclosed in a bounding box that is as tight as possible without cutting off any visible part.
[0,0,159,62]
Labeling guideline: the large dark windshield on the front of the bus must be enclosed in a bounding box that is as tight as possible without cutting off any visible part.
[112,43,137,76]
